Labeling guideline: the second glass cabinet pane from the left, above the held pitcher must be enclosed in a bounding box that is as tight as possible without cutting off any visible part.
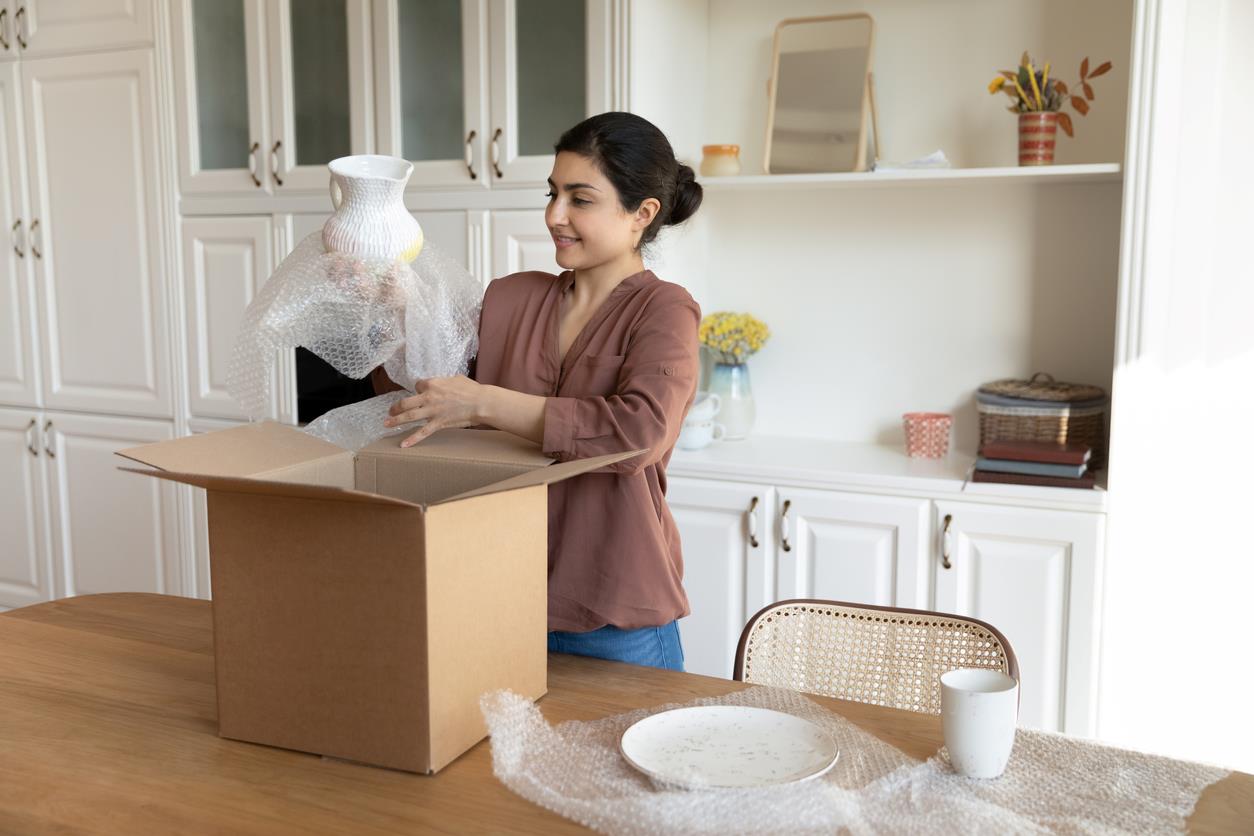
[290,0,352,165]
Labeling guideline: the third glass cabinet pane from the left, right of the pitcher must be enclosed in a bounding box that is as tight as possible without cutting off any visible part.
[396,0,465,162]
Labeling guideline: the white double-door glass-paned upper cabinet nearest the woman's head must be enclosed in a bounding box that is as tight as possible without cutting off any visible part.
[374,0,613,191]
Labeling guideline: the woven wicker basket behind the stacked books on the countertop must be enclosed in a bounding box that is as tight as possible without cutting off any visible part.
[976,374,1107,470]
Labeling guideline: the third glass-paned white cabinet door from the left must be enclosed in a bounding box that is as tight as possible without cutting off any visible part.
[374,0,492,191]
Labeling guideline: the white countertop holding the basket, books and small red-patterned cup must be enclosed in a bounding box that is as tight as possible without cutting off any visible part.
[667,436,1107,511]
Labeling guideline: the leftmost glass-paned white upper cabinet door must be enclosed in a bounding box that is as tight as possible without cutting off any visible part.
[172,0,271,196]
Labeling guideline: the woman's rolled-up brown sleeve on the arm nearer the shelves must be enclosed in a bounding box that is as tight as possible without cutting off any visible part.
[543,293,701,474]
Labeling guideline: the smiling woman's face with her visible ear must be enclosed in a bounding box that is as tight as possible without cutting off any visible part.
[544,150,657,269]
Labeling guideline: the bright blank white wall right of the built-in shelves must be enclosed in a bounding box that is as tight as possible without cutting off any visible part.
[1099,0,1254,771]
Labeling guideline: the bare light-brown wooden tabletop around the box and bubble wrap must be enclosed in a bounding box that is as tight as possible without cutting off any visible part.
[0,594,1254,833]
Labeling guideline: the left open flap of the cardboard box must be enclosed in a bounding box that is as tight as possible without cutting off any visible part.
[118,421,352,484]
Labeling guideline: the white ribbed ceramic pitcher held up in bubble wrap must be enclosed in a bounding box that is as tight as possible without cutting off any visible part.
[322,154,424,262]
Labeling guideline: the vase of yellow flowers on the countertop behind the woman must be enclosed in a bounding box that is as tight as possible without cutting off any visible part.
[698,311,771,440]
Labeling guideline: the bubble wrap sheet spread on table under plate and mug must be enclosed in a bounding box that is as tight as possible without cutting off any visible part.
[482,687,1226,835]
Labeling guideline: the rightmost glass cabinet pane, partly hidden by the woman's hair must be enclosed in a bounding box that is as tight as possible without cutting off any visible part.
[514,0,588,157]
